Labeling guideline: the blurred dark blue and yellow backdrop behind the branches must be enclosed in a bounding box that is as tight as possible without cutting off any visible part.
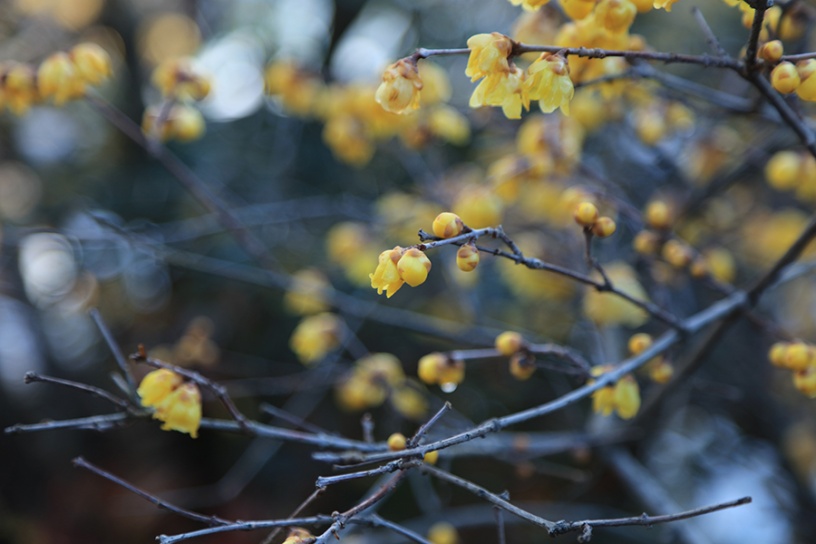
[0,0,816,543]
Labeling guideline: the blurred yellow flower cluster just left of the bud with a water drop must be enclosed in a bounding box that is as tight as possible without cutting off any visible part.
[336,353,427,420]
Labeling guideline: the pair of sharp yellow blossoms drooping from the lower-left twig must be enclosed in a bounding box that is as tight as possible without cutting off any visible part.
[136,368,201,438]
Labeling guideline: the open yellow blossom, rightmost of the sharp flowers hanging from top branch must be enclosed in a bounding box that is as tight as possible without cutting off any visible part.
[524,53,575,115]
